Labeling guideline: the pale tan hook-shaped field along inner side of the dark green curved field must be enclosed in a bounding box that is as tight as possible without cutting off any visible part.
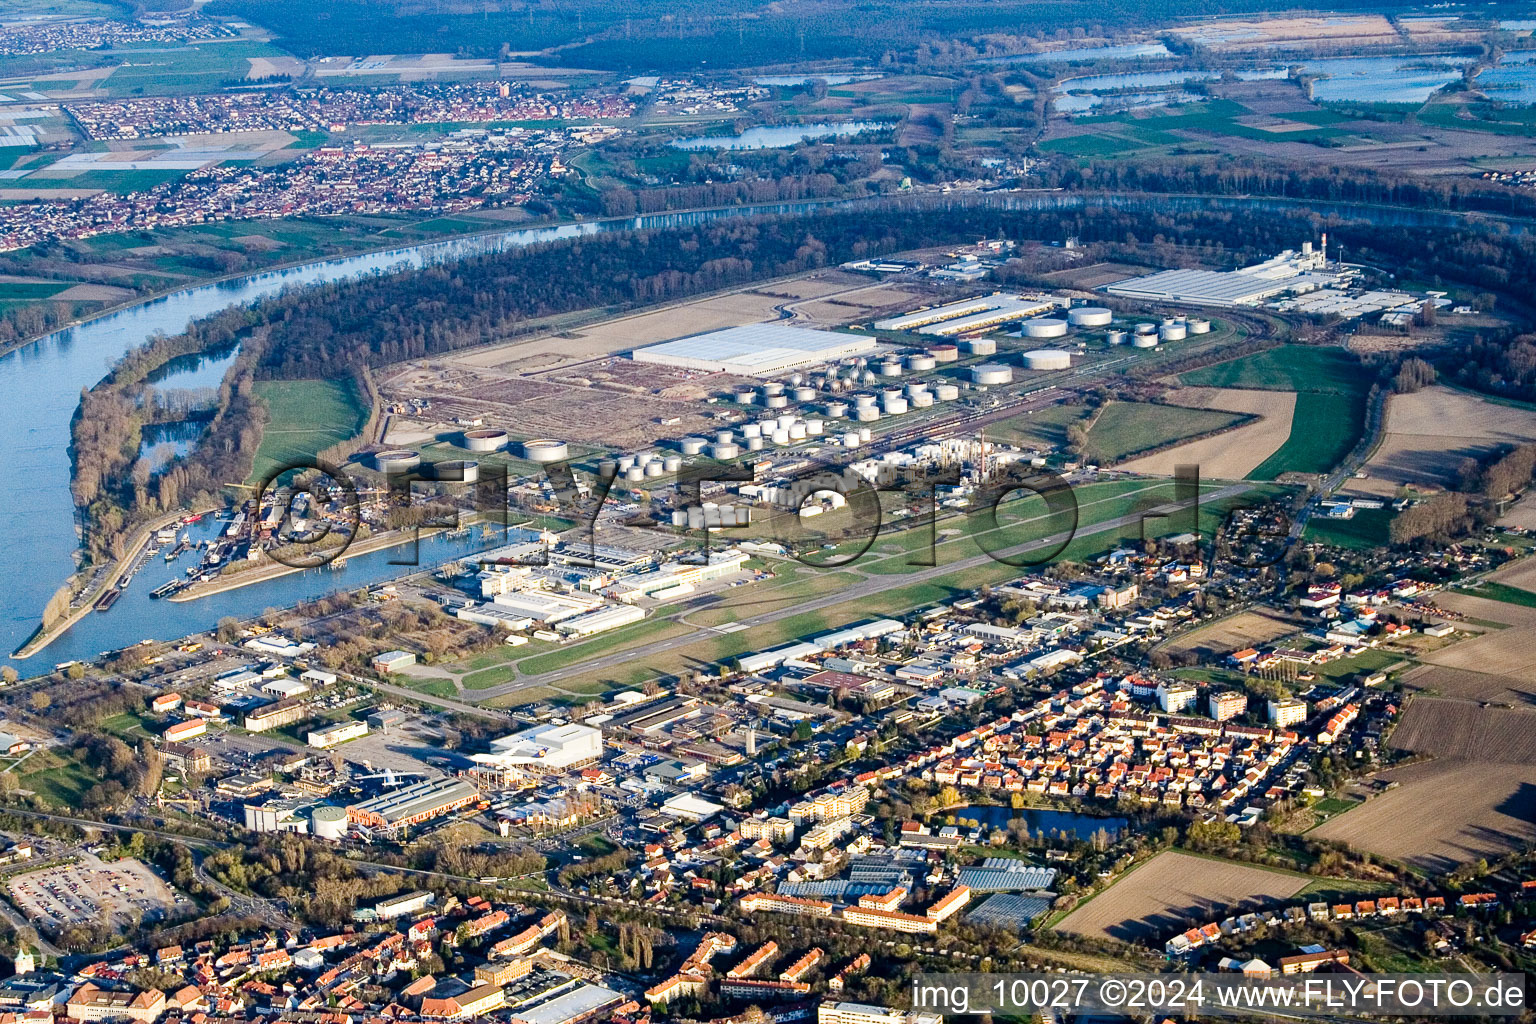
[1120,387,1296,481]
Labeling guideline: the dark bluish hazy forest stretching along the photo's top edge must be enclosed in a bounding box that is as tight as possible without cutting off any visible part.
[206,0,1400,72]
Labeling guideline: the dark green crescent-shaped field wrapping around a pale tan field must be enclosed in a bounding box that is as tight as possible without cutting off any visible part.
[1178,345,1370,481]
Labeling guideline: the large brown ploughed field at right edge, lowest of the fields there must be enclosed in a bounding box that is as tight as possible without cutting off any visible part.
[1307,758,1536,874]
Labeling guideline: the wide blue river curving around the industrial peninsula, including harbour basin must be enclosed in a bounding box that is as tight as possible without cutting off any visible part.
[0,192,1511,674]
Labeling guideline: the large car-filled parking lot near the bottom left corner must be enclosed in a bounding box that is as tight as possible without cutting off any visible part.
[8,855,186,927]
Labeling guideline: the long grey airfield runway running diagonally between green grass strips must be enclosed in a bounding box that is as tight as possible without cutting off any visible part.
[481,484,1249,699]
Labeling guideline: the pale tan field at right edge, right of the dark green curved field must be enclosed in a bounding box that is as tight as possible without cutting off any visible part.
[1352,387,1536,497]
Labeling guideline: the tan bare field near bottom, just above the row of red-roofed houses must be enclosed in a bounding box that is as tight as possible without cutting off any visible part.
[1057,851,1312,946]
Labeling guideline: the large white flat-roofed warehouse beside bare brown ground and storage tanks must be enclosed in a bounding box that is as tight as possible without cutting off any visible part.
[630,324,877,376]
